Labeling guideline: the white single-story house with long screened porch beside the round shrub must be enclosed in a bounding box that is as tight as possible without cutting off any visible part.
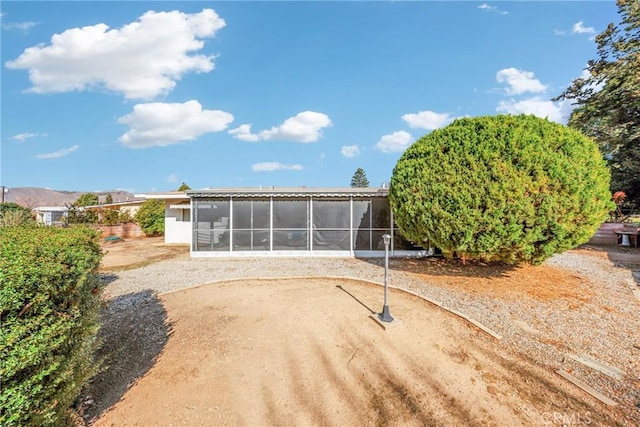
[141,188,431,257]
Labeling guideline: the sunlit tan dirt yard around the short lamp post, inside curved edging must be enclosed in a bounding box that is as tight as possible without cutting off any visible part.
[95,279,611,426]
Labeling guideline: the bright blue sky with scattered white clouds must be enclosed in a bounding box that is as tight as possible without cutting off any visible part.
[0,1,618,192]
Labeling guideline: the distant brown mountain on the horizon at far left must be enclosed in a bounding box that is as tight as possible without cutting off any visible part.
[4,187,136,209]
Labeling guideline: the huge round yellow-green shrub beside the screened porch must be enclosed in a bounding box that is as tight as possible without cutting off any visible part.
[389,115,612,264]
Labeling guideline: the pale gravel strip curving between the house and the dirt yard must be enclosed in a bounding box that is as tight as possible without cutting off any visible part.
[105,252,640,425]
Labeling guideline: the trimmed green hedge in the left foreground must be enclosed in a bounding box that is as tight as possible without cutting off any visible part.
[0,227,103,426]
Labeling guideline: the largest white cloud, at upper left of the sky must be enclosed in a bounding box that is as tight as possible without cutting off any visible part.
[6,9,225,99]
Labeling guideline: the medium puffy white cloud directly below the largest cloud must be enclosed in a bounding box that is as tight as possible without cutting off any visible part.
[118,100,233,148]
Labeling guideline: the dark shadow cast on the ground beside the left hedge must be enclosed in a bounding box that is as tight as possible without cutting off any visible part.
[78,290,170,422]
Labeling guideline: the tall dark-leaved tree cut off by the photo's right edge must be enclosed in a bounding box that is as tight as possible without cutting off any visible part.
[554,0,640,202]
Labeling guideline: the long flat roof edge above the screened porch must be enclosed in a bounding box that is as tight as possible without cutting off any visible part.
[187,187,389,197]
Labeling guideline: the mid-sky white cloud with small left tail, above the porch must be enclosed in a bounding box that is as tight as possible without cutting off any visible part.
[229,111,332,142]
